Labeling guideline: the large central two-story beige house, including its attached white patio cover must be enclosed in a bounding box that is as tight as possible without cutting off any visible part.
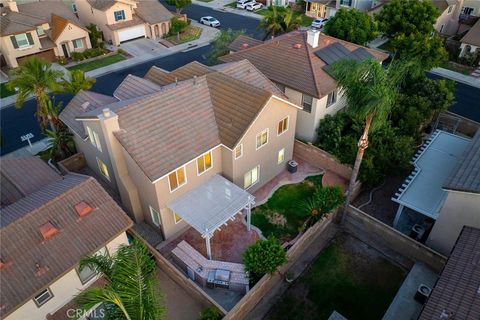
[60,61,299,246]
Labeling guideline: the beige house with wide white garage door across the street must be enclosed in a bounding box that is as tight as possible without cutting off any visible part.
[75,0,173,46]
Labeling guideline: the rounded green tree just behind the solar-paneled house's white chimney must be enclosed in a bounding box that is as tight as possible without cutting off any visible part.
[324,8,378,45]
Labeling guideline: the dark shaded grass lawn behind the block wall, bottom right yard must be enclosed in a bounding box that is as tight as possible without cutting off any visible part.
[267,235,406,320]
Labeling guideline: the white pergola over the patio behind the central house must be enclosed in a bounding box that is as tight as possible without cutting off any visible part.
[167,174,255,259]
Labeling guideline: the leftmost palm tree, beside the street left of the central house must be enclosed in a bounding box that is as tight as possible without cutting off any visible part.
[8,56,63,127]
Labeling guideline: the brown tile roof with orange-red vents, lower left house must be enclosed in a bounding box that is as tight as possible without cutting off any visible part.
[0,166,132,318]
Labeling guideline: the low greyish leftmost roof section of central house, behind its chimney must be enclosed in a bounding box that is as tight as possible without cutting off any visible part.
[60,91,118,139]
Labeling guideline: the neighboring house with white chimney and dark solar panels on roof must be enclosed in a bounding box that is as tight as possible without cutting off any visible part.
[220,30,388,142]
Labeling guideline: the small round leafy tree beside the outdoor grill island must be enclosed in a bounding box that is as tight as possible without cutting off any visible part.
[243,237,287,282]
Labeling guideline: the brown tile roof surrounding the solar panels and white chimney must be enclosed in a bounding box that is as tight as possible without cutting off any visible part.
[220,31,388,98]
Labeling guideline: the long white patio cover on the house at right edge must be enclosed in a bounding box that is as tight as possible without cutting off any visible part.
[392,130,469,222]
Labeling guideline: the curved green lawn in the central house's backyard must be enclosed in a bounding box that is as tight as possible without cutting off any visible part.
[252,175,322,241]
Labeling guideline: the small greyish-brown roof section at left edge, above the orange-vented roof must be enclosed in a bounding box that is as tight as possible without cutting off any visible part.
[0,157,61,206]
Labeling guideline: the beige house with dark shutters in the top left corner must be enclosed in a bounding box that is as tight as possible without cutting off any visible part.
[0,0,91,68]
